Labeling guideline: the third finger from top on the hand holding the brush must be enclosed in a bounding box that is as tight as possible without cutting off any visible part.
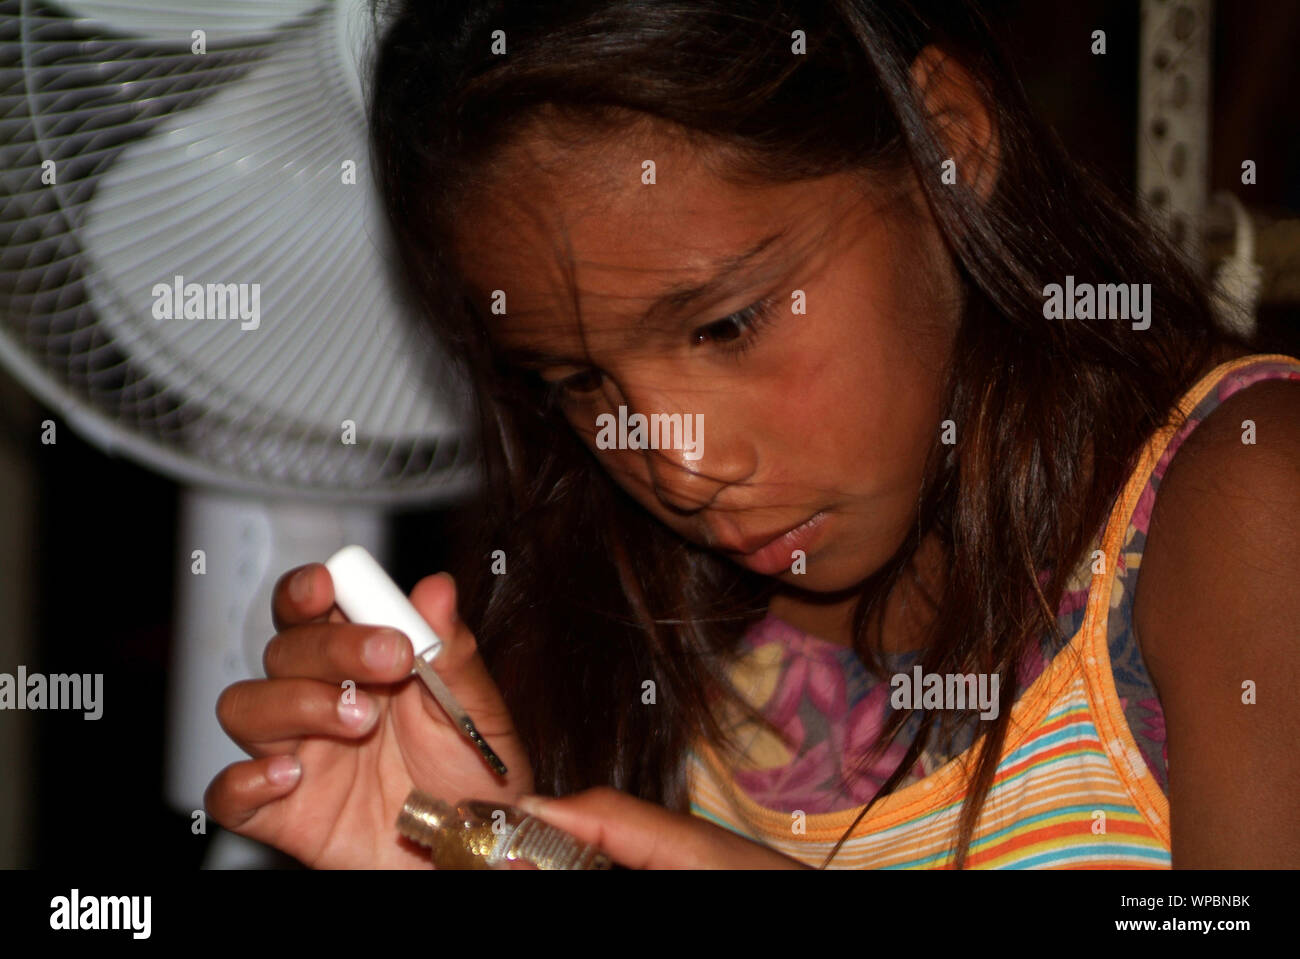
[217,678,380,756]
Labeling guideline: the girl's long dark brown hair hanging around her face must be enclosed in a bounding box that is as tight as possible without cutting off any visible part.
[369,0,1245,868]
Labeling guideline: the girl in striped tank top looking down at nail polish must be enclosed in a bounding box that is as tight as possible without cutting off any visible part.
[207,0,1300,868]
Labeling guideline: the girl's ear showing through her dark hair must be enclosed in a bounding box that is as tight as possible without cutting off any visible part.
[911,45,1001,200]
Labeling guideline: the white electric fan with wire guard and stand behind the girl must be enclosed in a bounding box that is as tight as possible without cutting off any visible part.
[0,0,478,865]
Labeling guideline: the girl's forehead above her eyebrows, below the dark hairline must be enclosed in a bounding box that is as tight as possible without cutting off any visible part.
[456,113,845,344]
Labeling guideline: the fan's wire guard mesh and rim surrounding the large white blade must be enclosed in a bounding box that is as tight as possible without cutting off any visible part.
[0,0,477,503]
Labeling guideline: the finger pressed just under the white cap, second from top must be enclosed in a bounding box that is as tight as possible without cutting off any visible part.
[261,622,413,682]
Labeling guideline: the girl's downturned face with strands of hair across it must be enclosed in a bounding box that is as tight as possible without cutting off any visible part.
[458,111,961,593]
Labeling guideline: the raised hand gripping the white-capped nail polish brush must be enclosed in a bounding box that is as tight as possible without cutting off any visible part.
[204,563,533,869]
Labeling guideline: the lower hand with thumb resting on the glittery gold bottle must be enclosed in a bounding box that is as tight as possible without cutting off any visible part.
[515,786,813,869]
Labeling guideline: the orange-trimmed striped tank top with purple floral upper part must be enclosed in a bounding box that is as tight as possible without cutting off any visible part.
[686,353,1300,869]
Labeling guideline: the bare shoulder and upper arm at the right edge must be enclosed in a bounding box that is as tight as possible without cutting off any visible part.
[1134,379,1300,867]
